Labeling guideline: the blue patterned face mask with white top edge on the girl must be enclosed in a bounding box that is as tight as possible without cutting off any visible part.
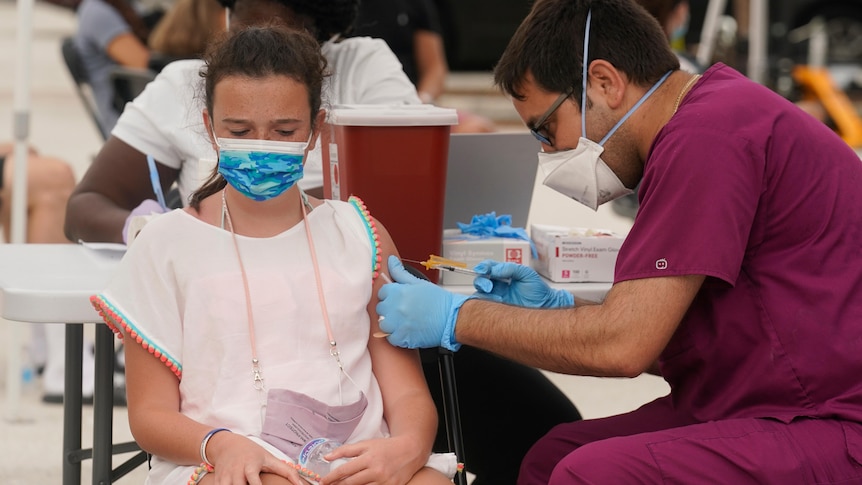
[216,138,308,201]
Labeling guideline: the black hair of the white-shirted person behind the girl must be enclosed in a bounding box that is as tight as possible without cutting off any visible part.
[218,0,359,43]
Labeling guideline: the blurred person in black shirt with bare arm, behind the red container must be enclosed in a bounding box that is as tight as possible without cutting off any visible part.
[351,0,496,133]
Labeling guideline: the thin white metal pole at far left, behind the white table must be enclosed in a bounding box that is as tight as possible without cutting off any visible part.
[6,0,35,420]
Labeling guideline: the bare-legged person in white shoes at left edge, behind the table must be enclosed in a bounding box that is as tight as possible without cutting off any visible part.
[0,143,94,404]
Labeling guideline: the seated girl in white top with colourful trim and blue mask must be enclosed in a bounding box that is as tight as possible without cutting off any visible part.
[93,26,456,485]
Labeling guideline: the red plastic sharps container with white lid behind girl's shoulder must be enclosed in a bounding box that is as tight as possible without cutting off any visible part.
[321,105,458,283]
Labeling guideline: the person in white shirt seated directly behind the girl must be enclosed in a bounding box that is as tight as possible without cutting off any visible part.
[65,0,420,246]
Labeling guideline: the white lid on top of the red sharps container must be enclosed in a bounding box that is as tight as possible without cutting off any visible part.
[329,104,458,126]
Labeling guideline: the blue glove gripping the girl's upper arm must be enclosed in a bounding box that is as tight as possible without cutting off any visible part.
[377,256,473,352]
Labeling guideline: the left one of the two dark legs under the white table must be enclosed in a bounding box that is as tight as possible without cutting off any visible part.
[63,323,84,485]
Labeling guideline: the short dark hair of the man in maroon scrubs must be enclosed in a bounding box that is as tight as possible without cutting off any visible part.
[494,0,679,106]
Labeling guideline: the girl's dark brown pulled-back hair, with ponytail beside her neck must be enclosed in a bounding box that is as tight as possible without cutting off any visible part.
[189,25,326,209]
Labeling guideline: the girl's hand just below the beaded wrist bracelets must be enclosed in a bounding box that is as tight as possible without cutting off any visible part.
[207,433,308,485]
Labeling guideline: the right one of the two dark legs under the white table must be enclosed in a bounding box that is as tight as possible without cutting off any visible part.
[92,325,114,485]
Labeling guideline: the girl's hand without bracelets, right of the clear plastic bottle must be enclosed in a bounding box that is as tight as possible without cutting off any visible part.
[320,436,428,485]
